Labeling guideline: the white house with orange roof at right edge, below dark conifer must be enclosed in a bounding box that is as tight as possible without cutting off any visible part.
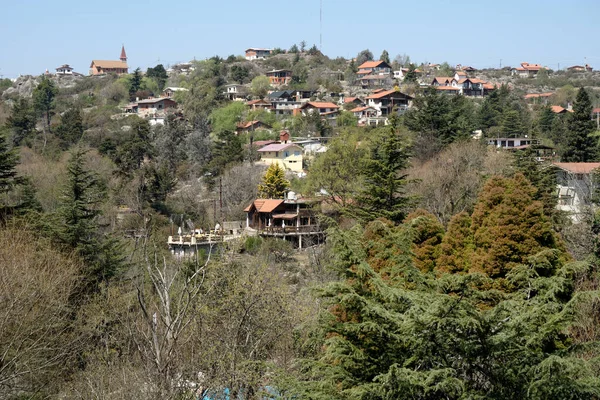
[553,162,600,222]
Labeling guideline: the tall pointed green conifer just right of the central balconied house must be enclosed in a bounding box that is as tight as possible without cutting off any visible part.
[351,116,409,223]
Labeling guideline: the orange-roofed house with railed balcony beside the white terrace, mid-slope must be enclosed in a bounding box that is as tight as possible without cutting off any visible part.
[244,192,323,248]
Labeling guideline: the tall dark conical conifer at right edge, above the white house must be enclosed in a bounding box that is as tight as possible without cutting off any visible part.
[561,88,598,162]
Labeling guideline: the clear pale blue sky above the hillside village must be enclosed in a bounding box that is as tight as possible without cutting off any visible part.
[0,0,600,78]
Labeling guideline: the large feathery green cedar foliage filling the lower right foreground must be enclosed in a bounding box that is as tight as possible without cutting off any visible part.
[296,221,600,400]
